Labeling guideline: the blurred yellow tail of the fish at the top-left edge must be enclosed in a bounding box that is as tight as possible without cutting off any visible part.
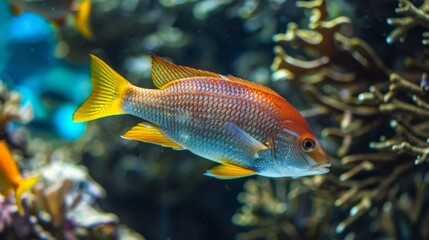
[75,0,94,40]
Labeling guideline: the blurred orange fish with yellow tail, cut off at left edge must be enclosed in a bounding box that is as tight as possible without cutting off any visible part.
[0,140,40,214]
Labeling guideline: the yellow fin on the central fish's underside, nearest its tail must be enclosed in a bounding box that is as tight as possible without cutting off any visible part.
[122,122,184,150]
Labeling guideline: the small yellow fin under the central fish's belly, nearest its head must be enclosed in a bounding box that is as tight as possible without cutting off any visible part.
[204,165,256,179]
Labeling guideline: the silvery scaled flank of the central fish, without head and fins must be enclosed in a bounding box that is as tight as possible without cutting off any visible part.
[123,78,281,170]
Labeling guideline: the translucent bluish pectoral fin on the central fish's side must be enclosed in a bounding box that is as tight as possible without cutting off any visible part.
[225,123,268,157]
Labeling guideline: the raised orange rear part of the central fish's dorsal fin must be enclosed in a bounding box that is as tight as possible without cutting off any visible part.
[152,54,221,89]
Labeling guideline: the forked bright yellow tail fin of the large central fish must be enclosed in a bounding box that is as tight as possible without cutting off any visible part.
[73,55,132,122]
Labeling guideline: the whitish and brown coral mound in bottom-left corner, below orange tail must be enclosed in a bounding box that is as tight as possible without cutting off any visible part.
[0,149,143,239]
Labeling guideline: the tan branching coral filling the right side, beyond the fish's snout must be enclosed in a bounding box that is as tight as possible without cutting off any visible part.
[234,0,429,239]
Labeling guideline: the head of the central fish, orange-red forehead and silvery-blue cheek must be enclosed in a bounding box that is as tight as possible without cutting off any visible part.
[272,124,331,177]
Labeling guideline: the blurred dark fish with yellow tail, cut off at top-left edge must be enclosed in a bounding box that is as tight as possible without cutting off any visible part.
[7,0,94,40]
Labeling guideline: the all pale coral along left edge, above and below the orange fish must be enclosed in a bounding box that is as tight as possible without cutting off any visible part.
[0,82,144,239]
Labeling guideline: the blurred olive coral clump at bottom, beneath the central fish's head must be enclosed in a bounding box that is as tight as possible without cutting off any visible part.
[232,177,332,240]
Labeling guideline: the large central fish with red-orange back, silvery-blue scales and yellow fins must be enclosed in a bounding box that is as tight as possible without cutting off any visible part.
[73,54,330,179]
